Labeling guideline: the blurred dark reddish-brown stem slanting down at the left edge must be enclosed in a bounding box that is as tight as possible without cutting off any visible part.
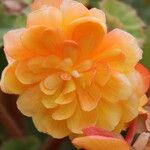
[0,102,23,138]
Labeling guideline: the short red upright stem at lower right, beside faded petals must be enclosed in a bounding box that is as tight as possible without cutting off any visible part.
[125,119,137,144]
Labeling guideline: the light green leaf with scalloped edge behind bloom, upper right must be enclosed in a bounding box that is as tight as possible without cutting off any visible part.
[100,0,145,45]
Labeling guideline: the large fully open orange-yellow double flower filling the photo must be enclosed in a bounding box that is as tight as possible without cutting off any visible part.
[1,0,149,138]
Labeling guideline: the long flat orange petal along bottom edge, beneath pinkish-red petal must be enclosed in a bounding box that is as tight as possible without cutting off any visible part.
[72,136,129,150]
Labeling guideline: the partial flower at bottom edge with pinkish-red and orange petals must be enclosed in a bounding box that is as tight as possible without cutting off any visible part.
[72,127,130,150]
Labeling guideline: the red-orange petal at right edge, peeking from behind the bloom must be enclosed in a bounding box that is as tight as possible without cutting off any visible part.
[135,64,150,92]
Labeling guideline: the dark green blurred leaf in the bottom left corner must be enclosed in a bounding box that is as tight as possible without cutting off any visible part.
[0,136,40,150]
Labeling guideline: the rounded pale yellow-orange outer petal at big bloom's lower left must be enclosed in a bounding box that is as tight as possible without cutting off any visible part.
[17,86,42,117]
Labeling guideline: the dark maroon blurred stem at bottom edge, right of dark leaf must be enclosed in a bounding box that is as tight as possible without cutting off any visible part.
[41,137,64,150]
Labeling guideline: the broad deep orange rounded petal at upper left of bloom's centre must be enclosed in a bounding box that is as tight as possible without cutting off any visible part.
[21,26,63,56]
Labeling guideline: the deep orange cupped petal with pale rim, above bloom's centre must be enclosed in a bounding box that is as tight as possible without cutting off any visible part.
[67,17,106,59]
